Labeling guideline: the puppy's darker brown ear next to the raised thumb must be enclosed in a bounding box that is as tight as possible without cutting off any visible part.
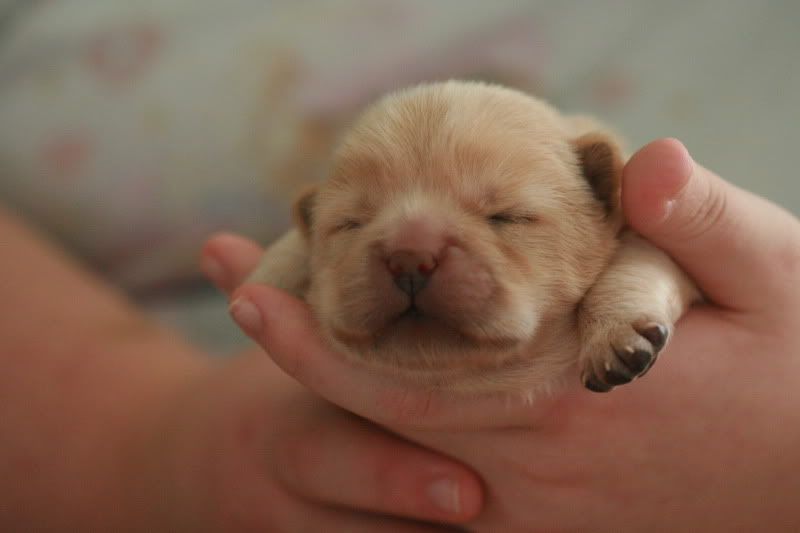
[573,132,624,219]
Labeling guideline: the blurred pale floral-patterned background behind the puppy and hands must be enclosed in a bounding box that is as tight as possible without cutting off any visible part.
[0,0,800,353]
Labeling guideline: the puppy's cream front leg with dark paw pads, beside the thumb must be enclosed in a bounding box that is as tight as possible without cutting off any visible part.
[579,232,700,392]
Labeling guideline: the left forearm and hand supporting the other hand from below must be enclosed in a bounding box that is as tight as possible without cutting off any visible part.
[0,209,482,532]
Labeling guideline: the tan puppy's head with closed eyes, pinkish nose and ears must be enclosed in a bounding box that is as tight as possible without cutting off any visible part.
[296,82,619,384]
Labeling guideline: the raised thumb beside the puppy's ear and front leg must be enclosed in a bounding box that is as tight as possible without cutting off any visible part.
[622,139,800,311]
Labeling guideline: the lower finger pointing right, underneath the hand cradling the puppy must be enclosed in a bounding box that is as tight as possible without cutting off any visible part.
[275,404,482,523]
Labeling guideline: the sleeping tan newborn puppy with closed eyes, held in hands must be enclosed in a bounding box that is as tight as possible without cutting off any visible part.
[251,81,697,395]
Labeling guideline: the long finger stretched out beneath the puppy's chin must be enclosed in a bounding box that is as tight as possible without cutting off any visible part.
[231,285,560,429]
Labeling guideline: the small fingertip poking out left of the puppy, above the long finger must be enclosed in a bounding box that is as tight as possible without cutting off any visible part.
[200,233,264,296]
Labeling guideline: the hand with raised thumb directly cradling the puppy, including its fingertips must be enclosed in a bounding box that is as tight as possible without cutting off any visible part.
[216,139,800,532]
